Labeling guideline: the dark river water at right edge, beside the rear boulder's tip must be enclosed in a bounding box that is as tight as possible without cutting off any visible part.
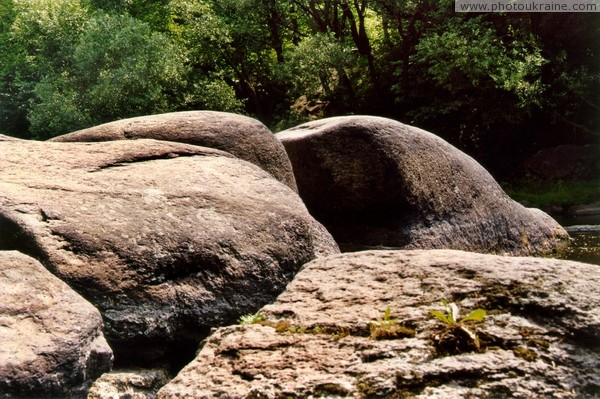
[553,215,600,265]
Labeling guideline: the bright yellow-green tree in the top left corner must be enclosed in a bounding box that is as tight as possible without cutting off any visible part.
[0,0,87,137]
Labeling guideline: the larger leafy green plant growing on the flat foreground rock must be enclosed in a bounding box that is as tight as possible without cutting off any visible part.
[429,300,487,353]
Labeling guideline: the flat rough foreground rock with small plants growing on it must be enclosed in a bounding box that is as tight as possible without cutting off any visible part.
[158,250,600,398]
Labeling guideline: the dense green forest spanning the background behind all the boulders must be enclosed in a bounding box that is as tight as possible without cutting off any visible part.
[0,0,600,177]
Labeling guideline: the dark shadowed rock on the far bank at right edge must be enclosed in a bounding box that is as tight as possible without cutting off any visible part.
[525,145,600,180]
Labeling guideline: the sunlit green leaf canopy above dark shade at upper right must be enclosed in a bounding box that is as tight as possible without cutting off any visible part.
[413,17,546,108]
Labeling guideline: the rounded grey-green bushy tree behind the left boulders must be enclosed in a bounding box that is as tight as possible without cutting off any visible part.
[28,13,182,138]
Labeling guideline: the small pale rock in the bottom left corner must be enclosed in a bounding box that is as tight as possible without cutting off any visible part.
[0,252,112,397]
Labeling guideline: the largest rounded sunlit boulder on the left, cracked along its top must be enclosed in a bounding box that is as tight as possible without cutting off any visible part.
[0,138,339,364]
